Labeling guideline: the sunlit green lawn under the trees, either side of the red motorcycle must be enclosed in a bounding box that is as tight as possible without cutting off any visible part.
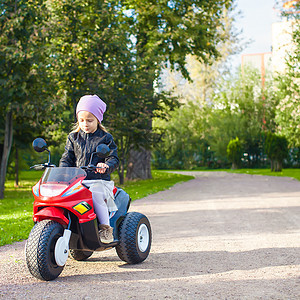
[0,171,194,246]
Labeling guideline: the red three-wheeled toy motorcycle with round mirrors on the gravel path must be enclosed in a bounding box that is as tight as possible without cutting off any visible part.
[25,138,152,281]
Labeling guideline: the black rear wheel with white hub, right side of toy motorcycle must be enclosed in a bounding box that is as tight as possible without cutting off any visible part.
[116,212,152,264]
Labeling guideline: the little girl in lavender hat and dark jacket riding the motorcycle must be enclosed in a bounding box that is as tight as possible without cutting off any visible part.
[59,95,119,243]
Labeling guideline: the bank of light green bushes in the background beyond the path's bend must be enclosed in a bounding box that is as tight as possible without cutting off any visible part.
[154,68,277,169]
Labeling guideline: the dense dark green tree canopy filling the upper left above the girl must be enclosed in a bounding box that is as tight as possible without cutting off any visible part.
[0,0,233,185]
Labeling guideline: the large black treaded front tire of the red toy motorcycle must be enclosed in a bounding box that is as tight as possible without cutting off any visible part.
[25,220,64,281]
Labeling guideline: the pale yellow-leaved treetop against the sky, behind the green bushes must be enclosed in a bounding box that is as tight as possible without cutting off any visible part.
[161,4,241,106]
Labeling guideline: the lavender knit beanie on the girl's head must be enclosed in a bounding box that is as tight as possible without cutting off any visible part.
[76,95,106,123]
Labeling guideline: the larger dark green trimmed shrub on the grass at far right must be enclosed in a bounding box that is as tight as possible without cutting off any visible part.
[266,132,288,172]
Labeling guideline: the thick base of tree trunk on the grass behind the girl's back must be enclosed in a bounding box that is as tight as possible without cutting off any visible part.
[126,149,152,180]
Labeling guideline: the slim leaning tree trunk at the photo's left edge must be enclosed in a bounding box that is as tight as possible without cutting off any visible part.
[0,110,13,199]
